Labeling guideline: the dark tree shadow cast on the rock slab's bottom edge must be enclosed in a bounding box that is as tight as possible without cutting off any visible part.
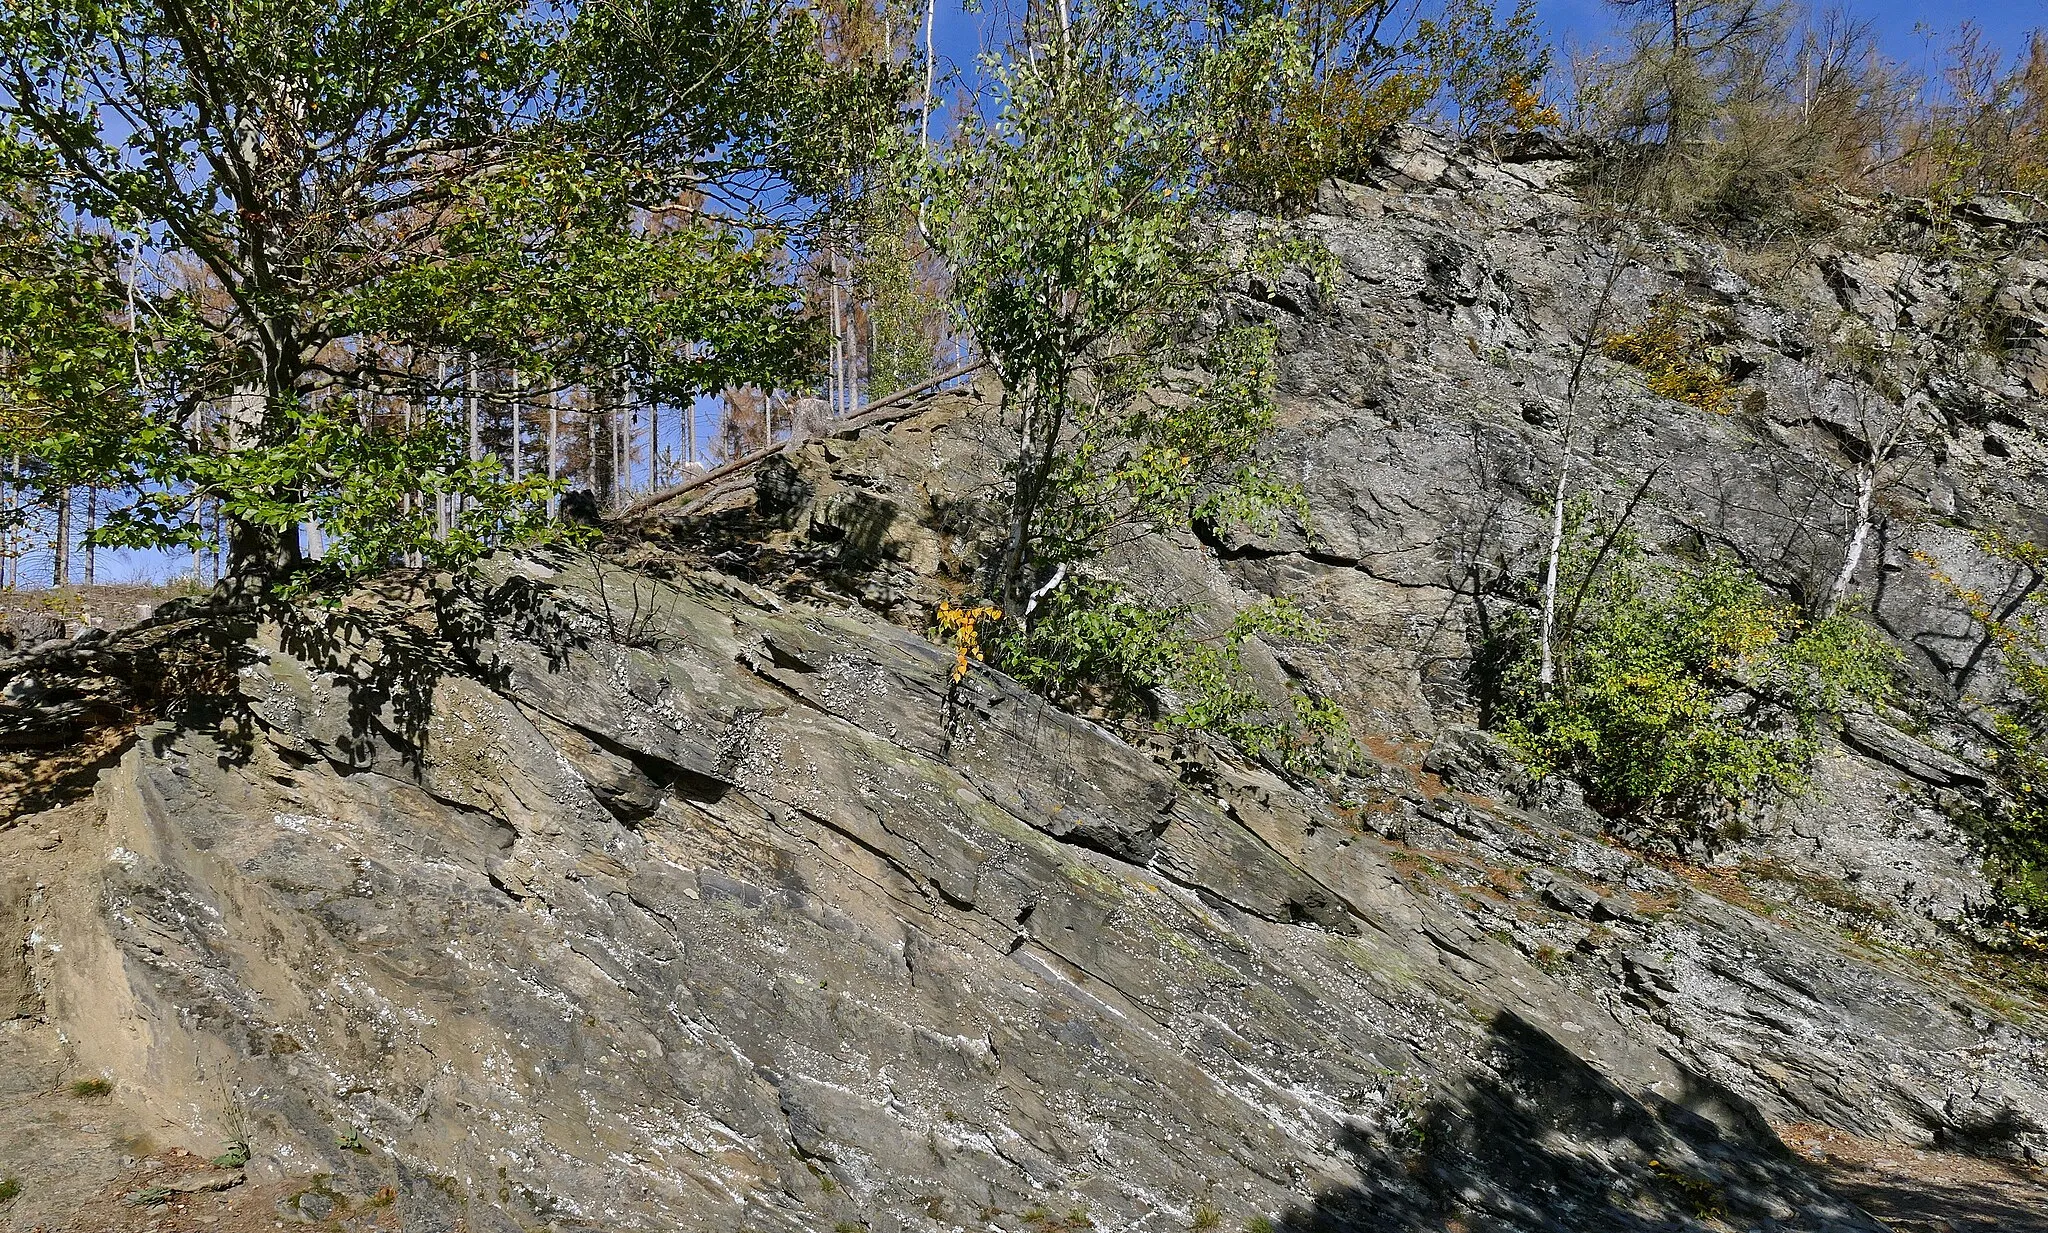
[1272,1010,1878,1233]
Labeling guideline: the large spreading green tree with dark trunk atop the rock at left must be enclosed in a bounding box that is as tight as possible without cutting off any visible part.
[0,0,887,580]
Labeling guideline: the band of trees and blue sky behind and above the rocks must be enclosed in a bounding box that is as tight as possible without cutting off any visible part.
[0,0,2048,588]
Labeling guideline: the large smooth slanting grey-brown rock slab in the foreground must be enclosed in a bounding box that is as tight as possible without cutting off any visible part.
[0,563,1982,1229]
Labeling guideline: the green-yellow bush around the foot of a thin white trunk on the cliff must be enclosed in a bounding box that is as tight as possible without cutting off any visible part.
[1491,543,1898,821]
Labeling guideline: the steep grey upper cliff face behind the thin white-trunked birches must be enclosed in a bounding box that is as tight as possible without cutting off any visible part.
[1225,134,2048,922]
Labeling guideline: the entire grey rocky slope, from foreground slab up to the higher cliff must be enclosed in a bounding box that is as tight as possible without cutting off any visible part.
[0,137,2048,1233]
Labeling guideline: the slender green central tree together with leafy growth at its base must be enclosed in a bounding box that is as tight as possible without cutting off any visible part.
[928,0,1343,770]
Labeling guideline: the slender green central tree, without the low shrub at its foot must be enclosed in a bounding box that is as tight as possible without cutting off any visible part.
[928,0,1284,623]
